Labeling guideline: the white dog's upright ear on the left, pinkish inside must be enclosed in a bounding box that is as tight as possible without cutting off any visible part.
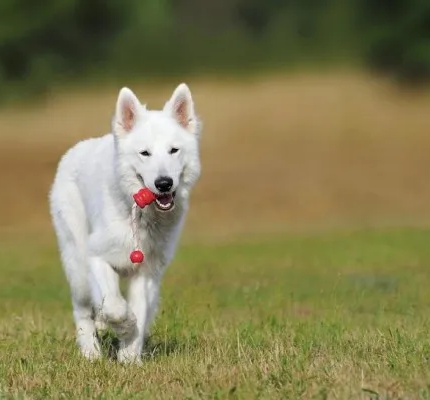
[114,87,140,136]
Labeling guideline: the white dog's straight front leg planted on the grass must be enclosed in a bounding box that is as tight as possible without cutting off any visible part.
[118,270,159,363]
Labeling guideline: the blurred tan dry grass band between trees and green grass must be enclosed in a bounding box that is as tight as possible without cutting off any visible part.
[0,73,430,239]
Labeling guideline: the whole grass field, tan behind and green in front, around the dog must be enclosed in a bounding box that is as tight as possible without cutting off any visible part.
[0,73,430,400]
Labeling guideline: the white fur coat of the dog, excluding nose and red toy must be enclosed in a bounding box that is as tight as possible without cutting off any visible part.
[50,83,200,363]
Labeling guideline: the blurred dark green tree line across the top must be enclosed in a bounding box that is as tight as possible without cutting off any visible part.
[0,0,430,97]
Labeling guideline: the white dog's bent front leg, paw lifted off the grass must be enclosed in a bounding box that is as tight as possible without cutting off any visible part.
[90,257,136,337]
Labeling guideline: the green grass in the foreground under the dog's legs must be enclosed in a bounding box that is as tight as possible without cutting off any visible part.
[0,230,430,399]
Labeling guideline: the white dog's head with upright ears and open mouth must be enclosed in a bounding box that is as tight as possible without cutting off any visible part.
[113,83,200,211]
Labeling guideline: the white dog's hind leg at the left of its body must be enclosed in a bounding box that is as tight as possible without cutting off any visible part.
[51,183,101,360]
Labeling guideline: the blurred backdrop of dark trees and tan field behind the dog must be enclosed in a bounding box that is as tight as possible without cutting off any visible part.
[0,0,430,239]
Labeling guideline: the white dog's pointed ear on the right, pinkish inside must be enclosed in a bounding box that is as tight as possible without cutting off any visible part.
[164,83,197,134]
